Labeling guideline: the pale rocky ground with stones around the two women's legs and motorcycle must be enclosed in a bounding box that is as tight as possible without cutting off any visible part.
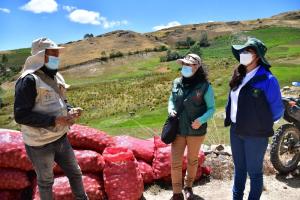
[144,146,300,200]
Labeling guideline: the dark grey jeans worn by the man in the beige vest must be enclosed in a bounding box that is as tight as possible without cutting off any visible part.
[25,135,88,200]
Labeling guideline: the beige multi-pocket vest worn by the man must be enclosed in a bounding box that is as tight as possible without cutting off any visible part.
[21,71,69,146]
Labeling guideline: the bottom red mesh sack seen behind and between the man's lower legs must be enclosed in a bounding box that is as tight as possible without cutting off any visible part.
[33,174,106,200]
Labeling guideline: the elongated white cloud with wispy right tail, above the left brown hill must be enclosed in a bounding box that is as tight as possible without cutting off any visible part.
[69,9,128,29]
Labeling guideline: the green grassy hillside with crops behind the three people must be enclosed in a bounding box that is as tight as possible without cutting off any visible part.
[0,27,300,143]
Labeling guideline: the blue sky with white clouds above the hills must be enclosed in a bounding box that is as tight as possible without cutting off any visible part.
[0,0,300,50]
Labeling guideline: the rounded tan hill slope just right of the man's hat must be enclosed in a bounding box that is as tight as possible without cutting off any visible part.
[61,31,161,67]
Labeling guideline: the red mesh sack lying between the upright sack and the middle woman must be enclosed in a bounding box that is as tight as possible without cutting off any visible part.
[112,136,154,163]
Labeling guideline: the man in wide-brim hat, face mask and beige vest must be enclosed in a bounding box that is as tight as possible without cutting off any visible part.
[14,38,88,200]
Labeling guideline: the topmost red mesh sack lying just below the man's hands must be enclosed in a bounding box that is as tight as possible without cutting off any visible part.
[68,124,112,153]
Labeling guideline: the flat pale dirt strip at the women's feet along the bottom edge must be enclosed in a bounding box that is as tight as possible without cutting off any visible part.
[144,174,300,200]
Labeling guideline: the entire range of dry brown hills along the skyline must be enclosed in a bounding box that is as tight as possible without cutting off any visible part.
[0,10,300,79]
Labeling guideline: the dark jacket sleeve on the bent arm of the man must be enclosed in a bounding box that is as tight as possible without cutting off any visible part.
[14,74,55,127]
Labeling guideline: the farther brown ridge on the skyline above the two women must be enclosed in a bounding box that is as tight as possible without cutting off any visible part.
[145,11,300,45]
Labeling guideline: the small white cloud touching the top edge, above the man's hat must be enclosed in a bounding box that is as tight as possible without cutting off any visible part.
[21,0,58,13]
